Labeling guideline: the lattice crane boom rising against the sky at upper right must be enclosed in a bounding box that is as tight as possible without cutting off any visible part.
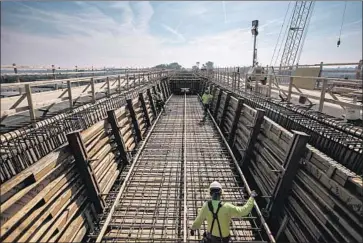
[280,1,314,71]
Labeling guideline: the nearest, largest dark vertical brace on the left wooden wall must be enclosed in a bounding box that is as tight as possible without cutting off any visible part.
[67,132,105,213]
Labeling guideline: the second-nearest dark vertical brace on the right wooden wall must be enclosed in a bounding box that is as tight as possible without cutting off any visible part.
[241,108,265,169]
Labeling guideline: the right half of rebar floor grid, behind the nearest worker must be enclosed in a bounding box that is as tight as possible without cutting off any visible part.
[186,96,263,242]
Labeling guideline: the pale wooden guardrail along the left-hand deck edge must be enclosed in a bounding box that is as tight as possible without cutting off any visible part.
[1,71,168,128]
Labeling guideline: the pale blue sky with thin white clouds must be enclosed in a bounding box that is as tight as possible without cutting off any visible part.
[1,1,362,67]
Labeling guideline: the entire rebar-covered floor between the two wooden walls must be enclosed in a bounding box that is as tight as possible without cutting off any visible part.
[94,96,263,242]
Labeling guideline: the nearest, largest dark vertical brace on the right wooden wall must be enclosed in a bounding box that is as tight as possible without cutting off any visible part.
[266,131,309,222]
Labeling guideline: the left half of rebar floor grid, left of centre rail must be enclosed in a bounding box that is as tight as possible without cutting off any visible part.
[96,99,184,242]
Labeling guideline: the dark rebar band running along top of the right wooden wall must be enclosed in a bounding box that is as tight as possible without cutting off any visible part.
[210,82,363,174]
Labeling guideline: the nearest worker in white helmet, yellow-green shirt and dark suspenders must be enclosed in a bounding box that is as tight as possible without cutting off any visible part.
[190,181,257,243]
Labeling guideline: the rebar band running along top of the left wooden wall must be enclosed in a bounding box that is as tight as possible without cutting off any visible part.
[0,77,170,182]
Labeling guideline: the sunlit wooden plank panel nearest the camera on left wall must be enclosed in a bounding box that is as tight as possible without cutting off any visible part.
[0,146,95,242]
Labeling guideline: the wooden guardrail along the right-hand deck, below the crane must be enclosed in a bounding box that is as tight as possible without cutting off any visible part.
[199,64,363,120]
